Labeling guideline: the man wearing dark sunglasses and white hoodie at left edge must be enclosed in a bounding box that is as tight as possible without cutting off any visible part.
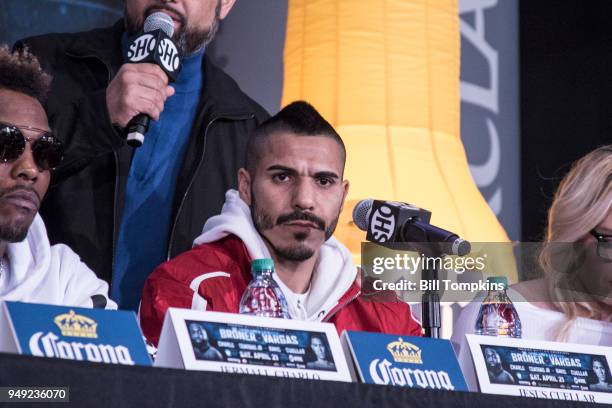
[0,47,116,309]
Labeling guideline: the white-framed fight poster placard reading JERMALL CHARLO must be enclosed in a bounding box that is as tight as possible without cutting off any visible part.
[155,308,351,382]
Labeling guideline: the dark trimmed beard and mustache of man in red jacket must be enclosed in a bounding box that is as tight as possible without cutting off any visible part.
[251,190,340,262]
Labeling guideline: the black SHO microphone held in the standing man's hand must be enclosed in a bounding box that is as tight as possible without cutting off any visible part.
[126,11,181,147]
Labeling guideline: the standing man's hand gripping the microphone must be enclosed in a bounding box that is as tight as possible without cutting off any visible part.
[106,63,174,128]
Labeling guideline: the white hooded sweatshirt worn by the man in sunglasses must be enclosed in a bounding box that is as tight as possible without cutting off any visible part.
[0,214,117,309]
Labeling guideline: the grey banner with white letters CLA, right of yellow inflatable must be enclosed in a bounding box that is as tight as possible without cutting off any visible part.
[459,0,520,237]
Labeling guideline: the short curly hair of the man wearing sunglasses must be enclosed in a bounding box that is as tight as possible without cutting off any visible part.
[0,45,51,104]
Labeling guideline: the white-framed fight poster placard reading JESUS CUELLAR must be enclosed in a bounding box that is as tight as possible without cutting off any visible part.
[466,334,612,404]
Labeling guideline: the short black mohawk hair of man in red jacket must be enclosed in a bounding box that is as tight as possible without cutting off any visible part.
[246,101,346,174]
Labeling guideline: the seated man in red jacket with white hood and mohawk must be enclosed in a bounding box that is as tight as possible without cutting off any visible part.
[140,102,421,344]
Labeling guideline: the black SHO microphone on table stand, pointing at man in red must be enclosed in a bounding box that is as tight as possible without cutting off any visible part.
[353,199,472,256]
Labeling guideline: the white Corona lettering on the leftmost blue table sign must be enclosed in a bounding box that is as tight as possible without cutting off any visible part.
[29,332,135,365]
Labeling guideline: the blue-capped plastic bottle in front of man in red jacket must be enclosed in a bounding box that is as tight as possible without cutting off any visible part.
[240,258,291,319]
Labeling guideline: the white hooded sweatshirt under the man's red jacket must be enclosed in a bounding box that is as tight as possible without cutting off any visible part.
[193,190,357,321]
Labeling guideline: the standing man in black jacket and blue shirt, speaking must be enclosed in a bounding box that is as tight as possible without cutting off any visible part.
[16,0,267,309]
